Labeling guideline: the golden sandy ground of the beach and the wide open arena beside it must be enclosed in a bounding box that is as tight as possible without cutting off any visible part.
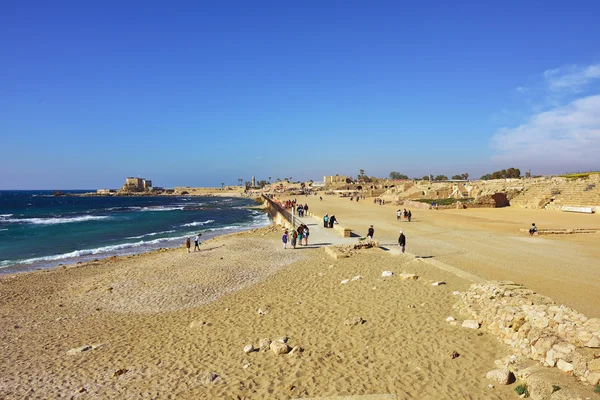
[0,196,600,399]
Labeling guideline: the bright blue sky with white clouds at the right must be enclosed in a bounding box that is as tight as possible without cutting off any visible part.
[0,0,600,189]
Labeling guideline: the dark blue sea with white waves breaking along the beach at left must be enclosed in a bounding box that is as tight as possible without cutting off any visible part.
[0,191,269,274]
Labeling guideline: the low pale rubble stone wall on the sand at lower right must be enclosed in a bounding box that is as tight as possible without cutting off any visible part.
[455,282,600,385]
